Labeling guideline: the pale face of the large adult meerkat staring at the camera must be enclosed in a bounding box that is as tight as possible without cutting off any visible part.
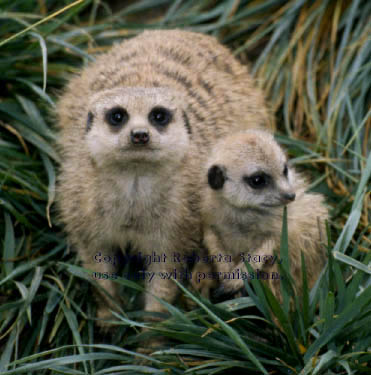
[85,87,191,168]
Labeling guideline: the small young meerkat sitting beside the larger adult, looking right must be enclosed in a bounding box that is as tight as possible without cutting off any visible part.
[198,130,328,299]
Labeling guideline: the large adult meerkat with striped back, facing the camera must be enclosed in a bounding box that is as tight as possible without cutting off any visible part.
[57,30,270,324]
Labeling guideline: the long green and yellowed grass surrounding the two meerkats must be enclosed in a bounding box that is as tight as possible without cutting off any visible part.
[0,0,371,375]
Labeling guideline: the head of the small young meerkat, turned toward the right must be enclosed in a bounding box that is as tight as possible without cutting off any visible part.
[207,130,295,210]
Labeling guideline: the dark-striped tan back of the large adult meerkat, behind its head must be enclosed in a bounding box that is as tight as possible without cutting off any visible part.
[57,30,273,156]
